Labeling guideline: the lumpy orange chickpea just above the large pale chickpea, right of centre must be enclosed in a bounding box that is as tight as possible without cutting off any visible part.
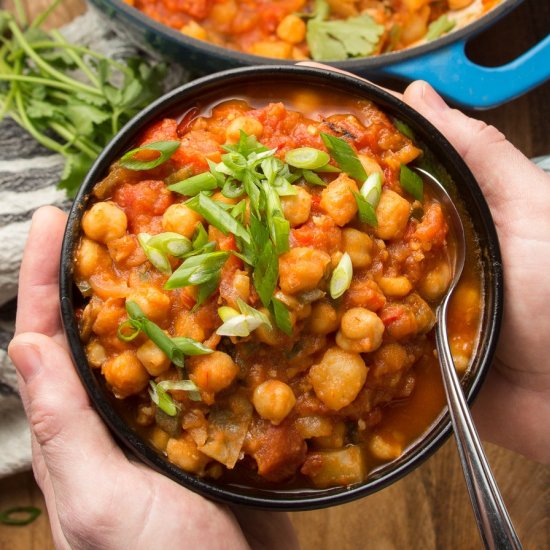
[336,307,385,353]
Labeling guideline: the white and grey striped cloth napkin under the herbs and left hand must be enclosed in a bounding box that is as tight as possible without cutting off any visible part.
[0,5,188,478]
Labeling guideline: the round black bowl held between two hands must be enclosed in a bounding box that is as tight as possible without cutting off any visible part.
[60,66,502,510]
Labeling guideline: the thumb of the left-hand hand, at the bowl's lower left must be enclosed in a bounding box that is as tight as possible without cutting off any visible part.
[8,333,123,494]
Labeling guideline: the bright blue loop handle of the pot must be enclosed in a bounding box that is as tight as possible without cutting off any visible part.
[381,35,550,109]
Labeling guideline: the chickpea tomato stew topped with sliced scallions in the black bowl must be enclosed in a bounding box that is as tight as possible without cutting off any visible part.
[74,86,483,489]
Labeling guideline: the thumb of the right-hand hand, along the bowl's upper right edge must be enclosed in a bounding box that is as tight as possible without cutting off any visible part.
[403,81,548,227]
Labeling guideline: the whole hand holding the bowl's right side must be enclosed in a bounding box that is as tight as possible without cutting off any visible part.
[403,82,550,462]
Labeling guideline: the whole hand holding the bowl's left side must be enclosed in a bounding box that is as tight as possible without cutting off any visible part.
[9,207,297,550]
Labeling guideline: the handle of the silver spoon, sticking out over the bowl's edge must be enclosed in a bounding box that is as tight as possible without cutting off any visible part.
[436,301,522,550]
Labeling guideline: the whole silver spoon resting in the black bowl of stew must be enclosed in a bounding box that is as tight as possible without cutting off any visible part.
[414,167,522,550]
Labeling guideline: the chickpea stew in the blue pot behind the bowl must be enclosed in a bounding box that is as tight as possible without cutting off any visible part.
[126,0,500,61]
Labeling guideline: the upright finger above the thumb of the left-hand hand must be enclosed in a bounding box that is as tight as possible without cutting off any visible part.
[16,206,67,336]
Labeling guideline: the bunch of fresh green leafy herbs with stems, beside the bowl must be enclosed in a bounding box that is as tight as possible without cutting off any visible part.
[0,0,165,196]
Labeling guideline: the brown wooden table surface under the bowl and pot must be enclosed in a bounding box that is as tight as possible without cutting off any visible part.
[0,0,550,550]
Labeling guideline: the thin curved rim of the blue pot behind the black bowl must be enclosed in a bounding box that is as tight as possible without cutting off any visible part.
[91,0,524,72]
